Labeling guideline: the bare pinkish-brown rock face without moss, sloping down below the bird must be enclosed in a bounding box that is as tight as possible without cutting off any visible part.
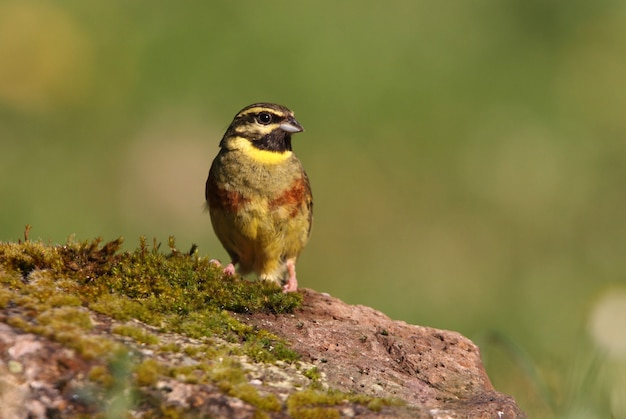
[238,290,525,418]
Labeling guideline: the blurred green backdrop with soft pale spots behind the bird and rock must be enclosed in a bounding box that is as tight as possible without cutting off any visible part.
[0,0,626,418]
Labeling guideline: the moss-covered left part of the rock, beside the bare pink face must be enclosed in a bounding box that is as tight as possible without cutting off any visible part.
[0,238,400,417]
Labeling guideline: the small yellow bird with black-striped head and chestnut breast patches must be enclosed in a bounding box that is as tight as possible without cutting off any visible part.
[205,103,313,292]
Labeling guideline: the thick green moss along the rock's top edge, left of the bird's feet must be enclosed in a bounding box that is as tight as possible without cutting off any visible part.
[0,238,302,362]
